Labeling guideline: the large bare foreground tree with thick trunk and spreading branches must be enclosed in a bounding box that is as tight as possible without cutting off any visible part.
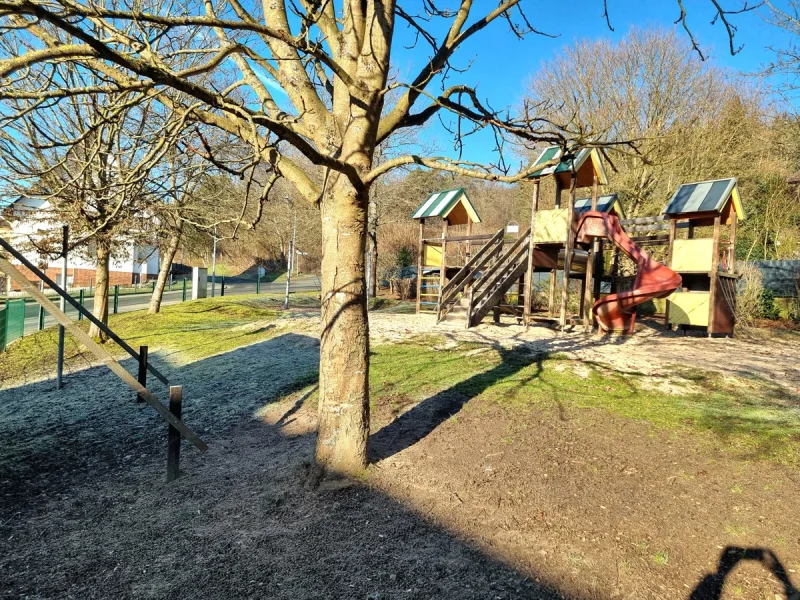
[0,0,752,473]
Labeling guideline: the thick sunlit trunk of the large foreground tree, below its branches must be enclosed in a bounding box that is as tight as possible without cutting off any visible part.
[316,176,369,474]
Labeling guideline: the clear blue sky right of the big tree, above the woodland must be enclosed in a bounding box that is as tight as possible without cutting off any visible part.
[393,0,787,169]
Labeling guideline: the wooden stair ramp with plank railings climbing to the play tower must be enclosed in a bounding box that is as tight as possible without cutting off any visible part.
[436,229,531,327]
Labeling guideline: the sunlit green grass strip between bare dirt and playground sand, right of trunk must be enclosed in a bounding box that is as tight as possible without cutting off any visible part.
[370,339,800,464]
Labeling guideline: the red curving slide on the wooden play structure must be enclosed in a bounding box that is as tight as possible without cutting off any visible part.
[577,211,681,333]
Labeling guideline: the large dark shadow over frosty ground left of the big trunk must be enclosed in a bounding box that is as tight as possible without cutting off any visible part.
[0,334,581,600]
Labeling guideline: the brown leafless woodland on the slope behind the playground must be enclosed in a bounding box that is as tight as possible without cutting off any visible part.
[192,29,800,279]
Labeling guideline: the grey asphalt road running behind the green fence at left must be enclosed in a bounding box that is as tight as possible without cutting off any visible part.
[19,275,319,335]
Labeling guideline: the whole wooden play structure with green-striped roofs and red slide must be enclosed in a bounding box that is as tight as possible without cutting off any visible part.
[413,147,744,335]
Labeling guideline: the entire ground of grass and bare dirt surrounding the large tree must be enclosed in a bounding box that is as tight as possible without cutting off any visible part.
[0,293,800,600]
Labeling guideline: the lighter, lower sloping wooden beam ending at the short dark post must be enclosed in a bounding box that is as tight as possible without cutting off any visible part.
[0,256,208,452]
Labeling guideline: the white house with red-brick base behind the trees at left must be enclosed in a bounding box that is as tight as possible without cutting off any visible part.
[0,198,159,287]
